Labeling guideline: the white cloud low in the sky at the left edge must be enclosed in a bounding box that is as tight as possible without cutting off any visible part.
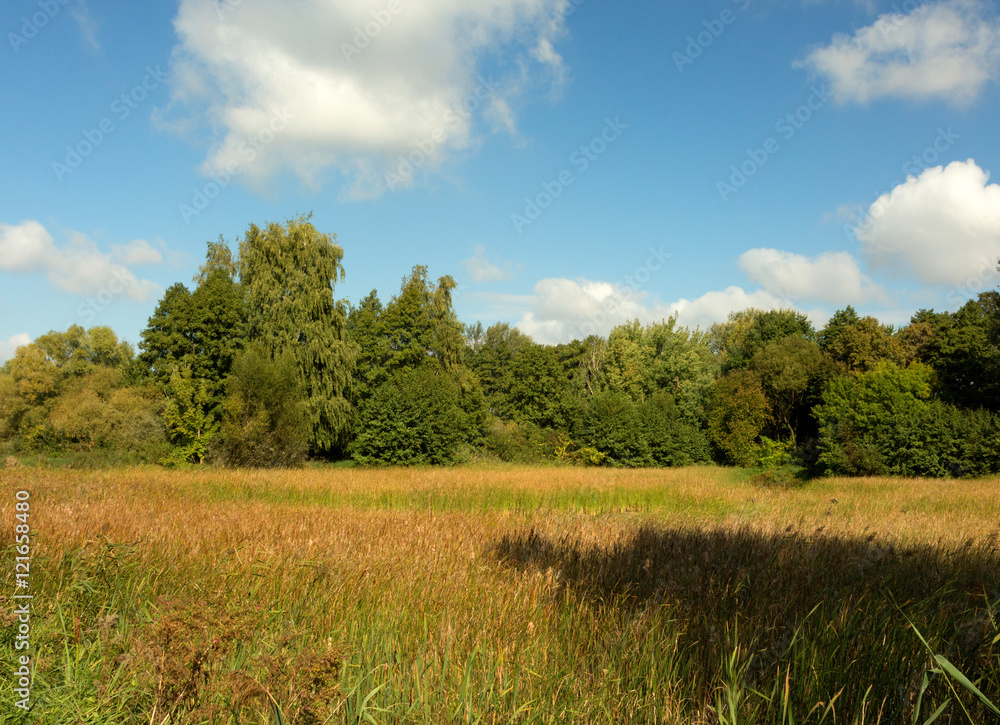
[0,220,161,301]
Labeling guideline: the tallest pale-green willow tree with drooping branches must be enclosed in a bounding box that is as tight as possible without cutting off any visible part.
[239,214,355,452]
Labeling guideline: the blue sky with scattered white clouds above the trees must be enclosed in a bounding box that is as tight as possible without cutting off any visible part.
[0,0,1000,359]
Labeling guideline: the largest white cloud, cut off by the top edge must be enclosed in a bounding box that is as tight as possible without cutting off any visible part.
[162,0,568,198]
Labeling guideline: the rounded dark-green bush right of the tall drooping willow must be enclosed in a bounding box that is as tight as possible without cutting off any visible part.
[351,366,473,466]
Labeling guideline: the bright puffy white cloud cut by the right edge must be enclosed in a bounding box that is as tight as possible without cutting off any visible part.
[854,159,1000,285]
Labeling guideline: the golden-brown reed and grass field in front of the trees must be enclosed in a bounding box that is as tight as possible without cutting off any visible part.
[0,466,1000,725]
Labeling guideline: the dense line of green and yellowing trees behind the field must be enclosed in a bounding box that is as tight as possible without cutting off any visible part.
[0,216,1000,476]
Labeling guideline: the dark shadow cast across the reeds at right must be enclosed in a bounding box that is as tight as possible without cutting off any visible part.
[493,526,1000,722]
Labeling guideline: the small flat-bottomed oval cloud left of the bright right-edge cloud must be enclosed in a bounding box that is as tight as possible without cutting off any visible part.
[739,248,885,306]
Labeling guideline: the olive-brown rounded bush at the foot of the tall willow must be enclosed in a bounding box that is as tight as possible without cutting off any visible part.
[211,344,309,468]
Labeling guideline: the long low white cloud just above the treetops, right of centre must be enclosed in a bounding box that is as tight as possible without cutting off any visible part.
[517,277,808,344]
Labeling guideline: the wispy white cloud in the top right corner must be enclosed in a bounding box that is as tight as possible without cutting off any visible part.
[795,0,1000,105]
